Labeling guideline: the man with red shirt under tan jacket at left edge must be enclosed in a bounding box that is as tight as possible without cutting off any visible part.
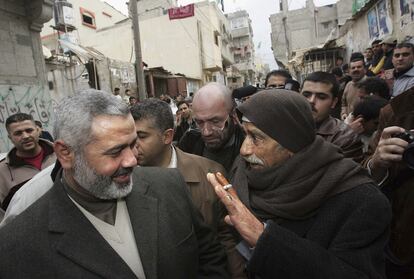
[0,113,56,210]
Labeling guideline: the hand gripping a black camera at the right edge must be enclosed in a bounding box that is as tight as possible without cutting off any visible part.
[370,126,408,172]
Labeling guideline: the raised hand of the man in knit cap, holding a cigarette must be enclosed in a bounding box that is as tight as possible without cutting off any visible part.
[207,173,264,247]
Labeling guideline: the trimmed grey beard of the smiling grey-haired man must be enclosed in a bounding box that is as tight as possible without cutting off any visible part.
[73,155,132,200]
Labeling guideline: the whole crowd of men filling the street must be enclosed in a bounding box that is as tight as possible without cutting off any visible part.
[0,38,414,279]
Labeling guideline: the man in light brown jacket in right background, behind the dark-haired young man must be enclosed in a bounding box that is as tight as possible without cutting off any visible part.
[341,53,366,120]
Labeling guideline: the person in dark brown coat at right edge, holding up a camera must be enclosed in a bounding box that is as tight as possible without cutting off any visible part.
[364,87,414,279]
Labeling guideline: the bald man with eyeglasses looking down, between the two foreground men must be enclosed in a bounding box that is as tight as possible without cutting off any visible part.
[178,82,244,171]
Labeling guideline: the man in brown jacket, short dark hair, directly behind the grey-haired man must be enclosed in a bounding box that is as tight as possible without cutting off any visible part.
[131,99,245,278]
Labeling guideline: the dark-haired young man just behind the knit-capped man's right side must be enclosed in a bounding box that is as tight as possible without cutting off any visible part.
[301,72,363,162]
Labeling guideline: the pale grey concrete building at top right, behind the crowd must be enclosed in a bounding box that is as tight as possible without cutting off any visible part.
[269,0,353,67]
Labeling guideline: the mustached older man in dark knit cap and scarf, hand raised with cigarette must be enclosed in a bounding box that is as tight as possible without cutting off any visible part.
[208,89,391,279]
